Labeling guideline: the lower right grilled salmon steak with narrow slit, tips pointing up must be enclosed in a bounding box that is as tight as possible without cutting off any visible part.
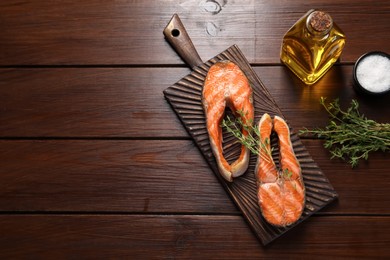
[255,114,305,227]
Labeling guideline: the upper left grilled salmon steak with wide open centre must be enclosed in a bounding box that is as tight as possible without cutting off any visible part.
[202,61,254,182]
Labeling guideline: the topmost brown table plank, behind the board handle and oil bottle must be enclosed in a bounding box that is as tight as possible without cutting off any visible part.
[0,0,390,65]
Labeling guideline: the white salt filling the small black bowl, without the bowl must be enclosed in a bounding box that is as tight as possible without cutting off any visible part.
[356,55,390,93]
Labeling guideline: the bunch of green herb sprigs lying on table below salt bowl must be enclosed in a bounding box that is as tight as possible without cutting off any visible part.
[299,97,390,167]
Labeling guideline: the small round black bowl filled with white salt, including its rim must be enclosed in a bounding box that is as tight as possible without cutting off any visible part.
[353,51,390,95]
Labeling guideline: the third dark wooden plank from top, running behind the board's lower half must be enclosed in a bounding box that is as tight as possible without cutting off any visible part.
[0,140,390,214]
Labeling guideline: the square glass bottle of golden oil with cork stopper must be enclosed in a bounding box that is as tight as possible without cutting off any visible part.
[280,9,345,85]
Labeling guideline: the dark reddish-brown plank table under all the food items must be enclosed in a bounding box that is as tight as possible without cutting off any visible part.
[0,0,390,259]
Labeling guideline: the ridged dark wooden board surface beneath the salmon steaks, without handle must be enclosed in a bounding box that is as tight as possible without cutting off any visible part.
[164,45,338,245]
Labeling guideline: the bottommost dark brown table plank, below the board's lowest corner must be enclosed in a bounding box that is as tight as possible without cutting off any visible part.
[0,215,390,259]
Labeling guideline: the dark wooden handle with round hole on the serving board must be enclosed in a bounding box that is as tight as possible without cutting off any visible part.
[163,14,203,68]
